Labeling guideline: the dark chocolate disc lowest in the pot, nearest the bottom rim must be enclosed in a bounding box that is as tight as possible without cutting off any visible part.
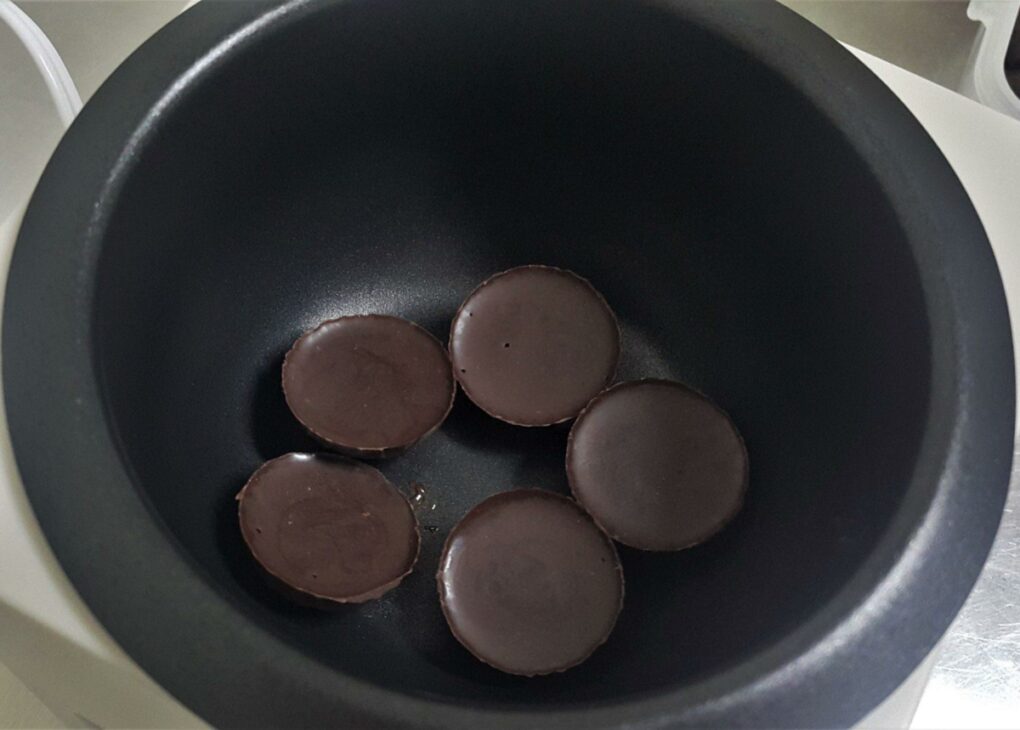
[437,489,623,676]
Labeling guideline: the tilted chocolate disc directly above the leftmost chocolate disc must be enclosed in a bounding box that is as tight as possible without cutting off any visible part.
[284,314,456,458]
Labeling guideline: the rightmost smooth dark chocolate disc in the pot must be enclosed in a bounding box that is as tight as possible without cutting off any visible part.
[567,380,748,551]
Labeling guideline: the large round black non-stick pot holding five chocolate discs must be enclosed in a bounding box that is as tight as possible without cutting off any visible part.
[3,0,1014,728]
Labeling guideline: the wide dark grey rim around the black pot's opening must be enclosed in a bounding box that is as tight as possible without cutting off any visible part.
[2,0,1015,728]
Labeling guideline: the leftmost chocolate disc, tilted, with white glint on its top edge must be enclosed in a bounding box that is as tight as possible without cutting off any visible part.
[237,454,419,604]
